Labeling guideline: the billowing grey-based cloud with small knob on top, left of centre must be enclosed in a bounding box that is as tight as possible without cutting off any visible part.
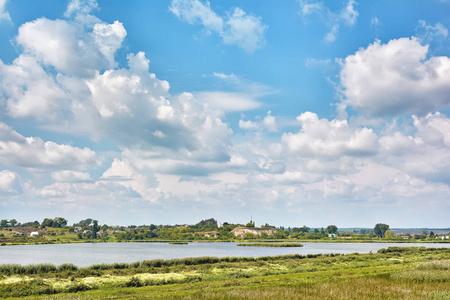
[87,52,231,164]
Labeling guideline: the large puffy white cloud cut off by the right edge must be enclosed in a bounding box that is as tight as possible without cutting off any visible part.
[340,37,450,116]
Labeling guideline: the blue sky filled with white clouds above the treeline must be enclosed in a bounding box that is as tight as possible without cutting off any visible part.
[0,0,450,228]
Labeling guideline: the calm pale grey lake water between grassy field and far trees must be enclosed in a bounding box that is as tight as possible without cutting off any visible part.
[0,243,450,267]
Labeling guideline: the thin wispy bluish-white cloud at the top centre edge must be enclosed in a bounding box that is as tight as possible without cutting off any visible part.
[169,0,268,53]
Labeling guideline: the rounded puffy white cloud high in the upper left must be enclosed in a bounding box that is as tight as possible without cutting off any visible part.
[16,18,126,77]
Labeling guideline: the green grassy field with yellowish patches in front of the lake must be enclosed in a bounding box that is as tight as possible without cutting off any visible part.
[0,247,450,299]
